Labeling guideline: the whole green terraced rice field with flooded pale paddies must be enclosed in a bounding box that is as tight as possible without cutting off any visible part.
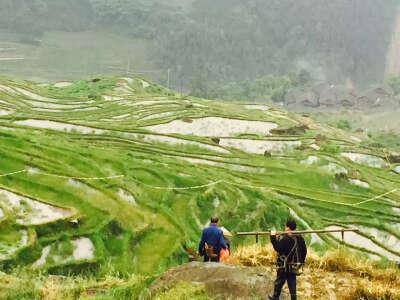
[0,78,400,273]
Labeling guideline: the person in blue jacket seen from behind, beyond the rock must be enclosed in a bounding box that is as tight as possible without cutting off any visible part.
[199,217,227,262]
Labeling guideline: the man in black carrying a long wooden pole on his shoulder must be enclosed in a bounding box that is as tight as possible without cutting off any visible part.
[268,220,307,300]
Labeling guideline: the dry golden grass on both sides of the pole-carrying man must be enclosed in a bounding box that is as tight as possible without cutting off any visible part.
[229,244,400,300]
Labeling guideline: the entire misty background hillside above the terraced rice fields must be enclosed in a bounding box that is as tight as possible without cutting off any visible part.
[0,0,398,89]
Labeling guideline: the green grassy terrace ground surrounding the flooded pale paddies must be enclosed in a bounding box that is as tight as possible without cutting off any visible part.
[0,78,400,298]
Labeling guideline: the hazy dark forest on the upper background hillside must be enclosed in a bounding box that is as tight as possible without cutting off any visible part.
[0,0,397,93]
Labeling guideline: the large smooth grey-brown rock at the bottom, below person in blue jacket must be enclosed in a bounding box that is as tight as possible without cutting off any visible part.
[150,262,289,300]
